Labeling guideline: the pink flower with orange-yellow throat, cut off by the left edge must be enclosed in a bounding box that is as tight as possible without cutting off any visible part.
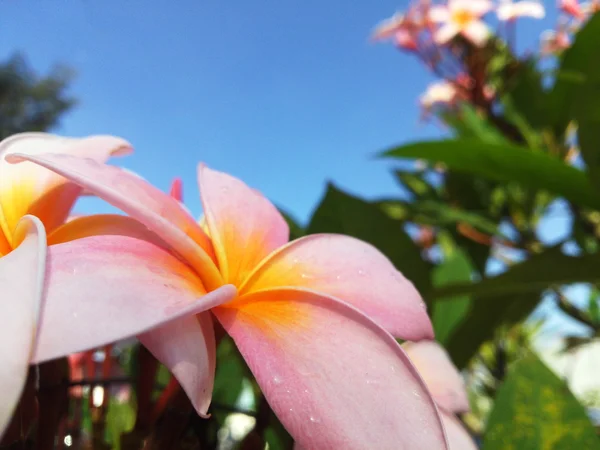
[0,133,130,437]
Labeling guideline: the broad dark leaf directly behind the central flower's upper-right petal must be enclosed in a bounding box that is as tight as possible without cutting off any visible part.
[307,184,431,292]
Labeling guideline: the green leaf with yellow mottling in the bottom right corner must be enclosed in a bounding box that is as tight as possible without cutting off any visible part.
[483,355,600,450]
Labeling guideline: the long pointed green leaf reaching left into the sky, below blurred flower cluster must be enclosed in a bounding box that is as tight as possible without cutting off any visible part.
[383,140,600,209]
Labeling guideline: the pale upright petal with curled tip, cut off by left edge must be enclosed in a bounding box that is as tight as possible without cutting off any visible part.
[0,216,46,438]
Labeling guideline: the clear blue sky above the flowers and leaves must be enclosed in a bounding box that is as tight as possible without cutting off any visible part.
[0,0,554,221]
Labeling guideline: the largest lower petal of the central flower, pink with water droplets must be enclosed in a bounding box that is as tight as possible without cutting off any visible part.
[213,291,447,450]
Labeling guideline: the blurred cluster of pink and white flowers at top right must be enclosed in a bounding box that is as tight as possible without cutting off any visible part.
[373,0,600,115]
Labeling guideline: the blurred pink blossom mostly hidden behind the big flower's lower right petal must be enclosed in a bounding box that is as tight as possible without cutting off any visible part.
[404,341,477,450]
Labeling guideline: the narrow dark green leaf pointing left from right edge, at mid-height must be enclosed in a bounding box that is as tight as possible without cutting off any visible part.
[429,247,600,299]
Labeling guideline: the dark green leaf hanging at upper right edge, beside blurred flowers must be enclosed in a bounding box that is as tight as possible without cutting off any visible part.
[547,14,600,136]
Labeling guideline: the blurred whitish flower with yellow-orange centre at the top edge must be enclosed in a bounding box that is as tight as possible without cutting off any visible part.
[429,0,493,47]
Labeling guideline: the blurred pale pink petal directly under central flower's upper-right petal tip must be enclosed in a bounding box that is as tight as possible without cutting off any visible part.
[404,341,469,413]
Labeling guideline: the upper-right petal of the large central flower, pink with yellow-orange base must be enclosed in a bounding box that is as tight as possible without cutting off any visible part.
[240,234,433,340]
